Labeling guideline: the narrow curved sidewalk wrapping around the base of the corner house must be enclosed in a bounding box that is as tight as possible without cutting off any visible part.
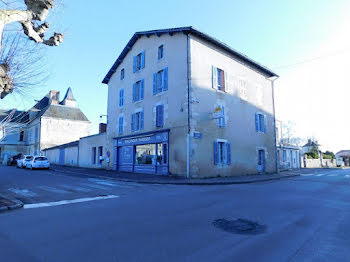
[51,165,300,185]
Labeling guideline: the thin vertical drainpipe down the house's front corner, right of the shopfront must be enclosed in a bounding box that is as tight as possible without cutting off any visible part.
[186,34,191,178]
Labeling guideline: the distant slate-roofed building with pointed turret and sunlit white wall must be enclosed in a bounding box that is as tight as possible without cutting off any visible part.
[0,88,91,161]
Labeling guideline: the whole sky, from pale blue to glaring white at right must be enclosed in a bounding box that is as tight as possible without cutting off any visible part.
[0,0,350,151]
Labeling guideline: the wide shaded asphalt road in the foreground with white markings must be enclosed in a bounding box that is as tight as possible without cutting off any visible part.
[0,167,350,262]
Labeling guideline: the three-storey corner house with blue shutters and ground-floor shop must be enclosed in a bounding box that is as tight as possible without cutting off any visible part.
[102,27,278,177]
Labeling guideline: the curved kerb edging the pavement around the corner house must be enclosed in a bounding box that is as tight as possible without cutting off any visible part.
[51,168,300,186]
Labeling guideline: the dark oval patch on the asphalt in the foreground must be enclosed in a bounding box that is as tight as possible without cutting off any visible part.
[213,218,267,235]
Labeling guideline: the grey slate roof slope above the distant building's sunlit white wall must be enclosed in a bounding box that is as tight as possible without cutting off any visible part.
[41,105,89,121]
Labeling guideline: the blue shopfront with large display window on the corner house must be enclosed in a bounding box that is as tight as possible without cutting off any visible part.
[114,130,169,174]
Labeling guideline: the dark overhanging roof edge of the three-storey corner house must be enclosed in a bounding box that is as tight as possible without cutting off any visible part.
[102,26,278,84]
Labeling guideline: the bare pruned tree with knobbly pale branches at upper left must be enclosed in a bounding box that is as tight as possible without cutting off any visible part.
[0,0,63,99]
